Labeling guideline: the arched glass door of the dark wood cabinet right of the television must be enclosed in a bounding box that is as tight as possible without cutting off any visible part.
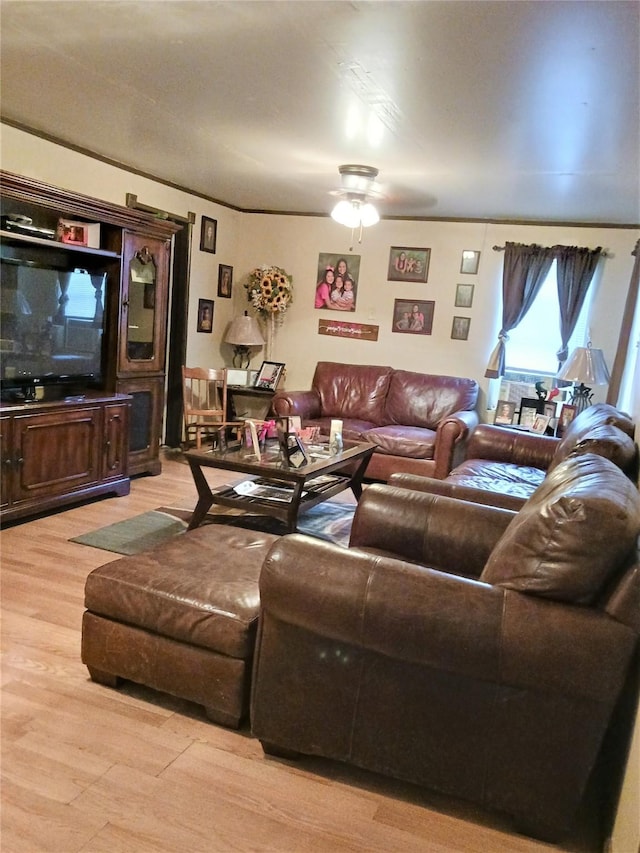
[118,234,168,373]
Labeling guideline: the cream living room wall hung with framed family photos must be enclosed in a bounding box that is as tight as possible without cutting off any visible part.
[1,125,640,412]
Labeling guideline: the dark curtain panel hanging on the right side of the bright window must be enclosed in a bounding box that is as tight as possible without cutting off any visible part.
[554,246,602,370]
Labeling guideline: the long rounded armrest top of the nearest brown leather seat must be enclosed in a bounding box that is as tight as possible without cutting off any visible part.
[258,534,635,700]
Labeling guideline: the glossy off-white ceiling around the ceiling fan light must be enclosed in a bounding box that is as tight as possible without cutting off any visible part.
[0,0,640,225]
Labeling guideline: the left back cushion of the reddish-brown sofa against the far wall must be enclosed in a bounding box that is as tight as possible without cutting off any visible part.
[313,361,392,424]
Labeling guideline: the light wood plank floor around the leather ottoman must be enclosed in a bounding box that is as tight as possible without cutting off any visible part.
[0,456,597,853]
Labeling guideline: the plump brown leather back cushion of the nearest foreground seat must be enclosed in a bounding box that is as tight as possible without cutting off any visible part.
[480,453,640,604]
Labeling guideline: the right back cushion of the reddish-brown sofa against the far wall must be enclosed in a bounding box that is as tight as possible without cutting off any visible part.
[384,370,478,429]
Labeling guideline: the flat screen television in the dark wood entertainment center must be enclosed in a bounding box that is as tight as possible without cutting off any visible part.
[0,258,107,400]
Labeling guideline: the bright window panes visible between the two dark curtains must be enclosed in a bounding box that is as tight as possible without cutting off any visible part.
[506,261,594,375]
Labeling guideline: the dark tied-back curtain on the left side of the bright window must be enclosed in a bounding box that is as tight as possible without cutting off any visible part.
[484,243,554,379]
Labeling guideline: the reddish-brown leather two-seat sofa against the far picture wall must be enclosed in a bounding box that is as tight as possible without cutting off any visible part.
[272,361,478,480]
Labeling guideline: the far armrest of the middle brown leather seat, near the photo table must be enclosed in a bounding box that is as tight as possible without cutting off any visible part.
[466,424,560,471]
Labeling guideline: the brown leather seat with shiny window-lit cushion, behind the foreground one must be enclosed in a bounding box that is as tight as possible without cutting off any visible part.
[389,403,638,510]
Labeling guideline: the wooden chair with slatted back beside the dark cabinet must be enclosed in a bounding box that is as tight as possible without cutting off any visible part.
[182,365,244,450]
